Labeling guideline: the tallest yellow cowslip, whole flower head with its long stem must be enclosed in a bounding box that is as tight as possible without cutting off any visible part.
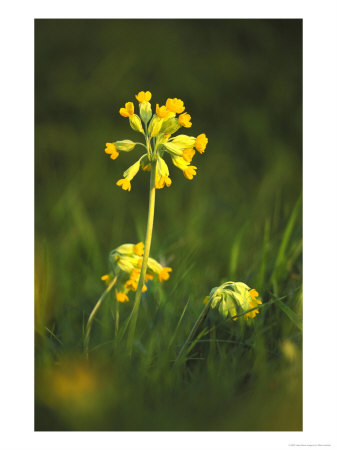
[105,91,208,354]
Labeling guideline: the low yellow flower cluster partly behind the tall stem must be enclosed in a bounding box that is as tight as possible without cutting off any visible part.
[101,242,172,303]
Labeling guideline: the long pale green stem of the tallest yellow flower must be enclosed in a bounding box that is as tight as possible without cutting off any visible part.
[127,162,156,356]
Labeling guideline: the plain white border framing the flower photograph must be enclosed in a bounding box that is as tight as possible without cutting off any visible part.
[0,0,337,450]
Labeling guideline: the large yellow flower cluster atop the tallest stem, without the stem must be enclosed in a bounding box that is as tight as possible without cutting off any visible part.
[105,91,208,191]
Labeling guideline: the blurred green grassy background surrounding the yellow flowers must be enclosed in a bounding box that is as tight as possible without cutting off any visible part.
[35,19,302,431]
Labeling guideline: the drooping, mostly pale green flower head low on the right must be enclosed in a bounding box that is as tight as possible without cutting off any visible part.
[209,281,262,322]
